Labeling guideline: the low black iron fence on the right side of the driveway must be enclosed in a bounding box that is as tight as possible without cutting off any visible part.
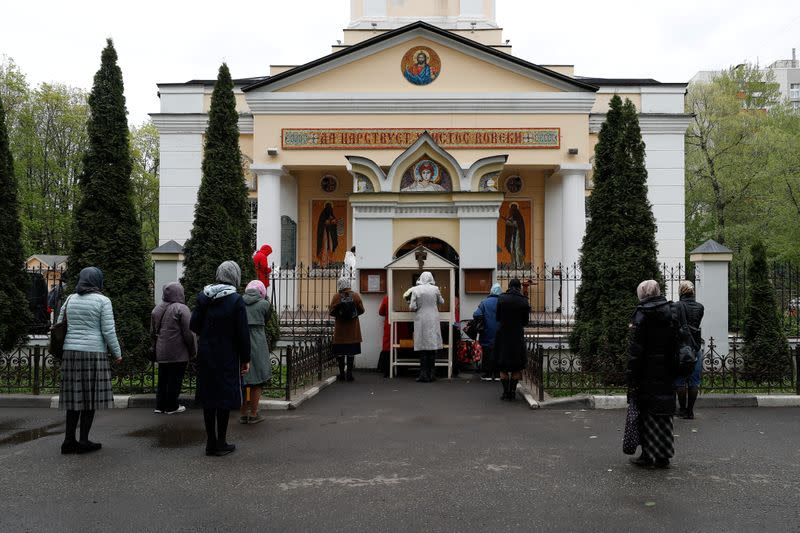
[524,338,800,401]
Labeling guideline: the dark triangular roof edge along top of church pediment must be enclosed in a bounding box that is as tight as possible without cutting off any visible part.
[242,20,598,92]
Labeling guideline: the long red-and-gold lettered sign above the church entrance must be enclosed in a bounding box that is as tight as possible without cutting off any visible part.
[281,128,561,150]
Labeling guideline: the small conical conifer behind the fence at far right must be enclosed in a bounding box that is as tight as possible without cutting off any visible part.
[744,242,792,383]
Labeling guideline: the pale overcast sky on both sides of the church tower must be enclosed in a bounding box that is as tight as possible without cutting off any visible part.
[0,0,800,124]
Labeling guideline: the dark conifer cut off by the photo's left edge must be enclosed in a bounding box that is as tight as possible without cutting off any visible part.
[0,98,30,351]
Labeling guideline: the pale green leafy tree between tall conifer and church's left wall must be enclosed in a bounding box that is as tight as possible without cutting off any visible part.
[131,121,159,250]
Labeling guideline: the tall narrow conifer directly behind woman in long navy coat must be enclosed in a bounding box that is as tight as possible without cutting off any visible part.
[183,63,254,302]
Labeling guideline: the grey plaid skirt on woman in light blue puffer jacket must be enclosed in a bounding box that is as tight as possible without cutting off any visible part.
[58,350,114,411]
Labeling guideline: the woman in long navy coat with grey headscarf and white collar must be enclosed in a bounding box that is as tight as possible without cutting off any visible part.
[190,261,250,457]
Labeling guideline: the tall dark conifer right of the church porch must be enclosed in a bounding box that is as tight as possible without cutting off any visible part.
[570,96,663,380]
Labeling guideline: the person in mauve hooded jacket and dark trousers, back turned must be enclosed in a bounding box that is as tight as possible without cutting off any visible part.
[150,281,197,415]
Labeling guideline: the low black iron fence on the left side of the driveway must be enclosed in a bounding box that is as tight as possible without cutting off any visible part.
[0,336,336,401]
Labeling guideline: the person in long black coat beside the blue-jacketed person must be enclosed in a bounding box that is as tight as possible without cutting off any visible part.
[494,278,531,401]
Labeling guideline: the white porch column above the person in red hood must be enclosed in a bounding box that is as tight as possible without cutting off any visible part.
[250,165,287,264]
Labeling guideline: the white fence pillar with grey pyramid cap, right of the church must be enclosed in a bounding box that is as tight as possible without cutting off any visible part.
[689,239,733,357]
